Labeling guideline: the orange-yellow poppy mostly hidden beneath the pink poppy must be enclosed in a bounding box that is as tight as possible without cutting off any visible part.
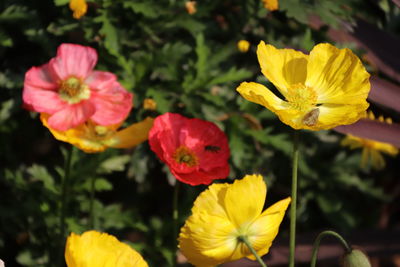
[40,113,154,153]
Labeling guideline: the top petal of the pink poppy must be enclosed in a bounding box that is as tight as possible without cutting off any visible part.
[49,44,97,80]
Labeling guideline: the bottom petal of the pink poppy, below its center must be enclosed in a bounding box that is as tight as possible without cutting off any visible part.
[48,101,95,131]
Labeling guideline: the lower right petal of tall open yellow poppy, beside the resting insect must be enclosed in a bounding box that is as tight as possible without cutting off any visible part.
[316,102,369,130]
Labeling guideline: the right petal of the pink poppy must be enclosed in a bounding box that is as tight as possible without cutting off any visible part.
[90,82,133,125]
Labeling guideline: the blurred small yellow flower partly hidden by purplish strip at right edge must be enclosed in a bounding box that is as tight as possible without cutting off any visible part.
[341,112,399,170]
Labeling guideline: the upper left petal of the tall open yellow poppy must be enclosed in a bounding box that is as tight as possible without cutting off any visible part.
[257,41,308,96]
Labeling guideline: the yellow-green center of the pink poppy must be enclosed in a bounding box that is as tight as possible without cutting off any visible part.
[58,77,90,104]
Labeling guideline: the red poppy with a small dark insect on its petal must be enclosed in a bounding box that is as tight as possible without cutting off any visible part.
[149,113,230,185]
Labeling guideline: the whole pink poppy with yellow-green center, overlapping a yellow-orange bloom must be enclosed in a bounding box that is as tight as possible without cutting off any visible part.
[23,44,132,131]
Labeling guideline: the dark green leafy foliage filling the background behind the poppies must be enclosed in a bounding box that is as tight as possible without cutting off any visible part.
[0,0,399,266]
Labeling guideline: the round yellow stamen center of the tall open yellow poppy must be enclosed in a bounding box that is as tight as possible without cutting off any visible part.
[286,83,317,111]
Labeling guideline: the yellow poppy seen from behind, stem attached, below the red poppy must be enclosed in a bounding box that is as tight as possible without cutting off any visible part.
[179,175,290,267]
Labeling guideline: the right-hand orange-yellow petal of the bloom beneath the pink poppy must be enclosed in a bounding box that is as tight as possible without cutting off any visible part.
[111,117,154,148]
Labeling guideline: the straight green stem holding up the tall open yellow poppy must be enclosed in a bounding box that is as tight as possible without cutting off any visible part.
[289,131,299,267]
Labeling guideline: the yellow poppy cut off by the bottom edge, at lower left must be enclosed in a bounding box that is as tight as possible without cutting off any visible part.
[65,231,148,267]
